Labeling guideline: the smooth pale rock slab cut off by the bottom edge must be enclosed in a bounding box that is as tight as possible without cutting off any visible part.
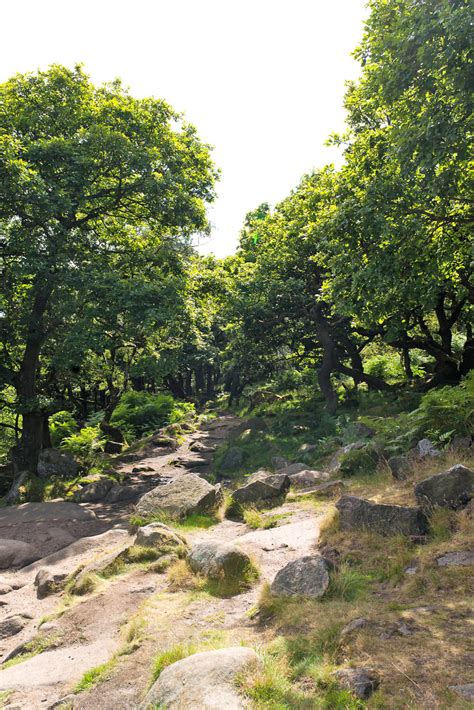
[140,646,261,710]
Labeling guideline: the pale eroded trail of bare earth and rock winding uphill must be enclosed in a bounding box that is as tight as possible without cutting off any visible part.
[0,415,326,710]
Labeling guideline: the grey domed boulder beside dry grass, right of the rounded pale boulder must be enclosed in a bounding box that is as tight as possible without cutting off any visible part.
[271,555,329,598]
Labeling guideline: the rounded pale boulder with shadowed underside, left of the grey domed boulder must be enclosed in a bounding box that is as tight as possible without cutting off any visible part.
[188,541,251,579]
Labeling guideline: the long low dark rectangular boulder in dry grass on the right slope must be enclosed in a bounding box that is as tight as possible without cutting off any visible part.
[336,496,429,537]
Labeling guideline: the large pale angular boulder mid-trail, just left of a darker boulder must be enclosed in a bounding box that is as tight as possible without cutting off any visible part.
[136,473,223,518]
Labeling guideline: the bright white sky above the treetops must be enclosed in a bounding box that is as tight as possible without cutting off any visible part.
[0,0,367,256]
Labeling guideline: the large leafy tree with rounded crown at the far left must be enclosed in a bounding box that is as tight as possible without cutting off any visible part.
[0,66,215,478]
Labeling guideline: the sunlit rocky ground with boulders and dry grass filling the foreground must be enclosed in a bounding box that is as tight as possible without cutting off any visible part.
[0,414,474,710]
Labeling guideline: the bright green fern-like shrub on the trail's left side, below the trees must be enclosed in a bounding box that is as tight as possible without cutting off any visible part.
[111,390,194,440]
